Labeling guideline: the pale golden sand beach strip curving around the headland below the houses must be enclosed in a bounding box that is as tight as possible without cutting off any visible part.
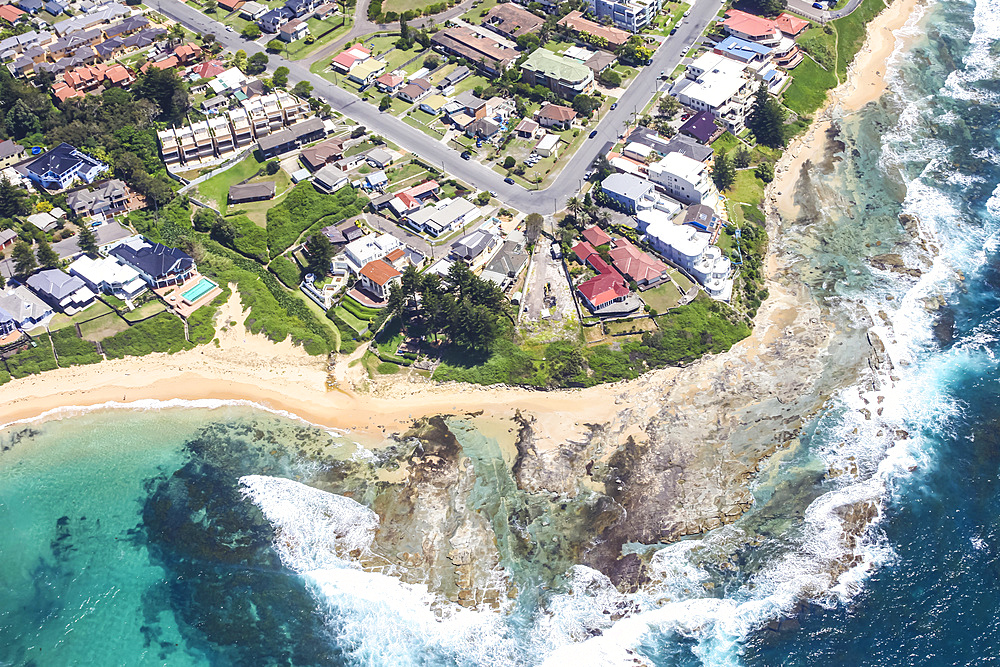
[0,0,918,462]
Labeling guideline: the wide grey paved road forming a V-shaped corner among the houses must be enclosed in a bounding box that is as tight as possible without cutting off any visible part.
[149,0,722,214]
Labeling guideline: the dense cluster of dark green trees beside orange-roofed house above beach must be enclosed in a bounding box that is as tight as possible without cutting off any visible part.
[385,262,512,353]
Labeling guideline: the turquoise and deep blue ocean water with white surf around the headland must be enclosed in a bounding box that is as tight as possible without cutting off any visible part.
[0,0,1000,667]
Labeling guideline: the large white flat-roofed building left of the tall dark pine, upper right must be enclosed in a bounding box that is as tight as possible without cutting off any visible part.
[670,53,758,134]
